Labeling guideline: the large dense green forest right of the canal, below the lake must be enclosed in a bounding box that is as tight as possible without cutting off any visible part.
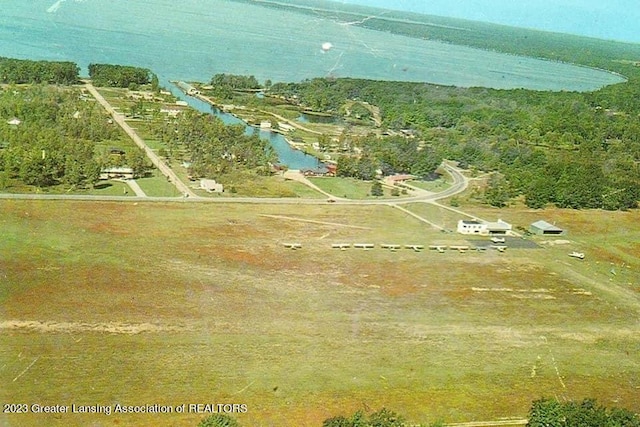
[270,69,640,209]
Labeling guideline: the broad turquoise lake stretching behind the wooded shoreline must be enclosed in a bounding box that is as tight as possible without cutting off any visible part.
[0,0,623,91]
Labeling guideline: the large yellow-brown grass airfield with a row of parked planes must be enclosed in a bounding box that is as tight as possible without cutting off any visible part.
[0,200,640,426]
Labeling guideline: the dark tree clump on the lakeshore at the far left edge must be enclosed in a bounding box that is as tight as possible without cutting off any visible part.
[0,57,80,85]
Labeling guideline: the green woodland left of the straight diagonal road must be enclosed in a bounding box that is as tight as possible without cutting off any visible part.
[0,85,131,188]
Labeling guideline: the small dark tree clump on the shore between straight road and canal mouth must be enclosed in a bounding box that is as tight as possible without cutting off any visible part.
[89,64,158,90]
